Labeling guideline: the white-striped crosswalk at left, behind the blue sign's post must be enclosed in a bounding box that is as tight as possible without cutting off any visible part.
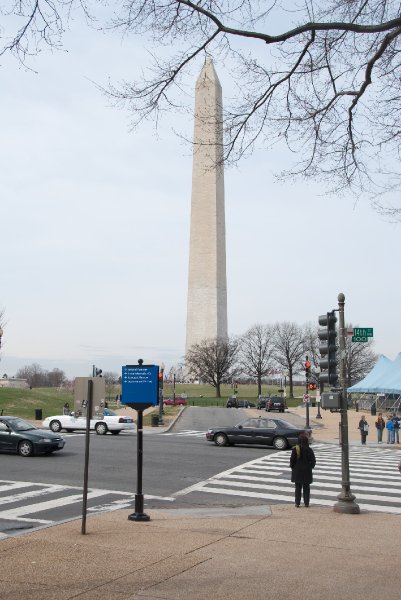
[0,480,174,540]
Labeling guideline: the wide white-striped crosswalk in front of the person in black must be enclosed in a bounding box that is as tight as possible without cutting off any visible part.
[175,444,401,515]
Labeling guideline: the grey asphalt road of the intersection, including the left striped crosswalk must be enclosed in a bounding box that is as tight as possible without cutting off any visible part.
[0,407,284,531]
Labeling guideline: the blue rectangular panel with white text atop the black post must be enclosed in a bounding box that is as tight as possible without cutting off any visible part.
[121,365,159,406]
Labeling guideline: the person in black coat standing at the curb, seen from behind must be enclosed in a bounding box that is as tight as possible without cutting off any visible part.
[290,435,316,508]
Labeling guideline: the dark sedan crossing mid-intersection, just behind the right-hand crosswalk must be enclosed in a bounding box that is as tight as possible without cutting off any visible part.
[206,417,312,450]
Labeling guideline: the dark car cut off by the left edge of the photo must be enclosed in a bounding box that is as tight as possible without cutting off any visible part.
[0,416,65,456]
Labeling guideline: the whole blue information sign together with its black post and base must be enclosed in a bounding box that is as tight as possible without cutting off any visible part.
[121,359,159,521]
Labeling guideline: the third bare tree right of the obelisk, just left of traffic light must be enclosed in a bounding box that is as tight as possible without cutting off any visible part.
[274,321,307,398]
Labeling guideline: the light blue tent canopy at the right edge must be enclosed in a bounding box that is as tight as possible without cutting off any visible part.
[347,352,401,394]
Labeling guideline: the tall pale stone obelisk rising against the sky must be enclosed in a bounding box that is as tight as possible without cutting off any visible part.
[186,59,227,350]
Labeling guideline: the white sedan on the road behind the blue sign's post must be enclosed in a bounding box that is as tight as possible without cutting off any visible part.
[42,408,135,435]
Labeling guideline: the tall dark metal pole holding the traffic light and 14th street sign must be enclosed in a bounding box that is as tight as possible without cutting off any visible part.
[334,293,360,514]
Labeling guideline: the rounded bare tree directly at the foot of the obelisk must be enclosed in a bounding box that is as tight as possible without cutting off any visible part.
[185,338,239,398]
